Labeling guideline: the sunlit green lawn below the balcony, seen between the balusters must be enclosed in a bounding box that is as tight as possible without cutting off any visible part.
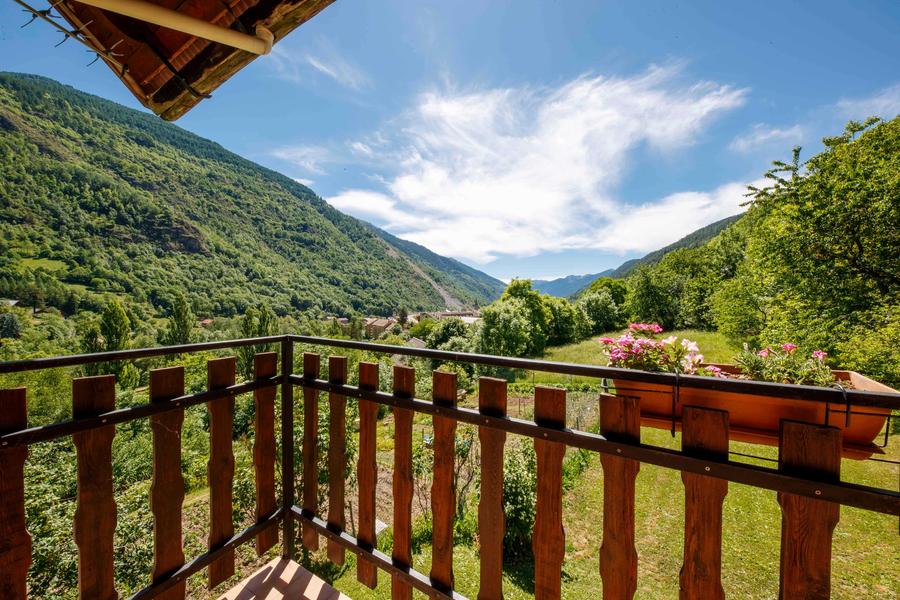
[320,428,900,600]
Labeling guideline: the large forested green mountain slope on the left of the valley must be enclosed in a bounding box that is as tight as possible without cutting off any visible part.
[0,73,502,315]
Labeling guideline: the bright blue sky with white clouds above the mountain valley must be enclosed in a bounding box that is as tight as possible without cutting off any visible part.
[0,0,900,279]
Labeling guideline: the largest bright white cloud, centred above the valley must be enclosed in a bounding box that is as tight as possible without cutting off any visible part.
[329,67,747,263]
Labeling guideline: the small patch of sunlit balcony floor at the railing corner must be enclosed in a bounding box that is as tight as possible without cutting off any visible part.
[219,558,351,600]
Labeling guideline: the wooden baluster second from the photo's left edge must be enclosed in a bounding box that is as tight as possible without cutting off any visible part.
[72,375,119,600]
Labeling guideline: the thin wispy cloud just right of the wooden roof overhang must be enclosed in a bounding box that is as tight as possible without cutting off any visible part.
[267,42,372,91]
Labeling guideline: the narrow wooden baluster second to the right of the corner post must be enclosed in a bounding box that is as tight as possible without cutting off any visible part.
[328,356,347,565]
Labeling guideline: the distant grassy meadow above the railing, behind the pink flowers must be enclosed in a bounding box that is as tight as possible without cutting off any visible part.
[518,329,740,384]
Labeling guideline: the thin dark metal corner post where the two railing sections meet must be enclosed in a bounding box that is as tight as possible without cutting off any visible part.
[281,336,294,560]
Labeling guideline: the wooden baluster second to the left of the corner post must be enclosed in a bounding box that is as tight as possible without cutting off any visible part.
[206,356,235,589]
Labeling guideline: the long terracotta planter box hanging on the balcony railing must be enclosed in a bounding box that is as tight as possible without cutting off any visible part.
[612,365,896,458]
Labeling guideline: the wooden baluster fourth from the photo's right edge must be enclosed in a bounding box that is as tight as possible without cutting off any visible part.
[532,387,566,600]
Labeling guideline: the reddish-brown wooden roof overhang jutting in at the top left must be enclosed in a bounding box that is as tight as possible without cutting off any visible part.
[51,0,334,121]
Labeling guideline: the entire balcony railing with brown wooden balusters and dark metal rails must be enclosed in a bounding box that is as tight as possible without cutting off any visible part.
[0,335,900,600]
